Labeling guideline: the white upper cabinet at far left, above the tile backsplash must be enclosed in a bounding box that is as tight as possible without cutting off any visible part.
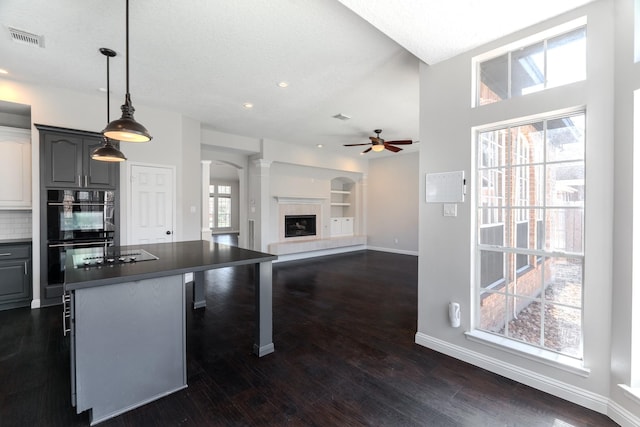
[0,126,31,209]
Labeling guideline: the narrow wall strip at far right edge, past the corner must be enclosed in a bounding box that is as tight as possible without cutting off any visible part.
[610,0,640,417]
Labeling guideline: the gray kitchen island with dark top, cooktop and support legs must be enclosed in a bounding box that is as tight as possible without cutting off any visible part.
[64,241,277,425]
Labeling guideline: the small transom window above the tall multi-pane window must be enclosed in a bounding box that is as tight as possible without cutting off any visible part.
[475,27,587,106]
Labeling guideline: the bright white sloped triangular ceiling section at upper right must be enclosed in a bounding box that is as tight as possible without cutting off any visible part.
[339,0,594,64]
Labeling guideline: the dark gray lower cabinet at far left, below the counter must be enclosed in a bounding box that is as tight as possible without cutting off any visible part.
[0,242,32,310]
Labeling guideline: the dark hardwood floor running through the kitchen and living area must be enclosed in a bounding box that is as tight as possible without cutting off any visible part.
[0,251,616,427]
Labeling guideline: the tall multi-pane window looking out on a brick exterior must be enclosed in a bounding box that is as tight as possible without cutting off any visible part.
[476,112,585,359]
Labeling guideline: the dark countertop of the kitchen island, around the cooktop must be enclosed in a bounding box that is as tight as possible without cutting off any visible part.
[64,240,278,291]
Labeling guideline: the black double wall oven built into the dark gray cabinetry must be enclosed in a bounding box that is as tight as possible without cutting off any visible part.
[46,190,116,285]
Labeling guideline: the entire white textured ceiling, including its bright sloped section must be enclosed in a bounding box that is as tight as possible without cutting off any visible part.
[0,0,588,155]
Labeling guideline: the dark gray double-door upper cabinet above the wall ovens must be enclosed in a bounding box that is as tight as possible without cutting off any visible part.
[36,125,119,189]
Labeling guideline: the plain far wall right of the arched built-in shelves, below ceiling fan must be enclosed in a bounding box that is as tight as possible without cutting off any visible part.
[367,153,420,255]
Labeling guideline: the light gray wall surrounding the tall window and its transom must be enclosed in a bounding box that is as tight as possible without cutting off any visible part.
[416,0,640,422]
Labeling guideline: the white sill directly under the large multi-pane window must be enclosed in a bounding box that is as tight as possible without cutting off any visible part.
[465,330,591,378]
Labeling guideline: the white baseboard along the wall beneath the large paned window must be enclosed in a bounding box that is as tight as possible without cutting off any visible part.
[415,332,609,414]
